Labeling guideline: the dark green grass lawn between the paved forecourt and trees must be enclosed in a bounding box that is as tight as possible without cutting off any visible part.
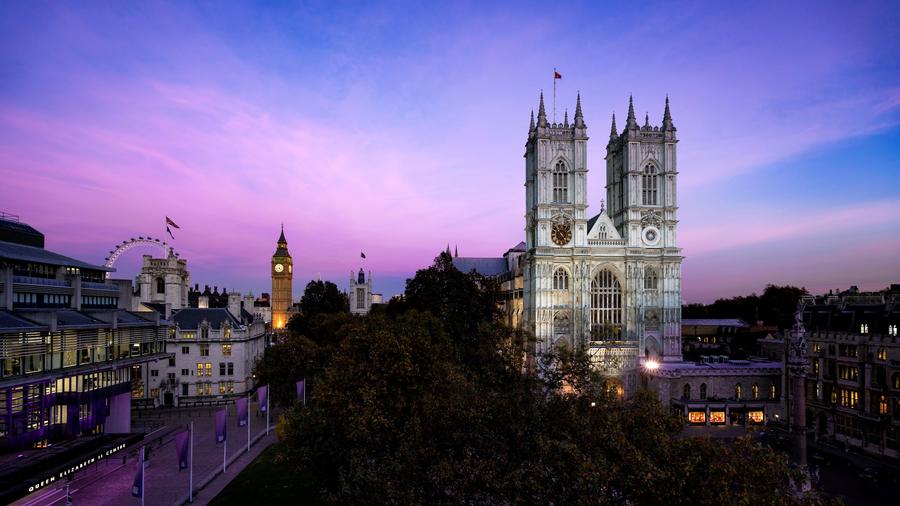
[209,443,318,506]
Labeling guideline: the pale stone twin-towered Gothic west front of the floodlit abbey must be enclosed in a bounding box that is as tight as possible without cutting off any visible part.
[521,94,682,394]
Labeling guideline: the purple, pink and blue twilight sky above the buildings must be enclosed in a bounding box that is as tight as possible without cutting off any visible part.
[0,2,900,303]
